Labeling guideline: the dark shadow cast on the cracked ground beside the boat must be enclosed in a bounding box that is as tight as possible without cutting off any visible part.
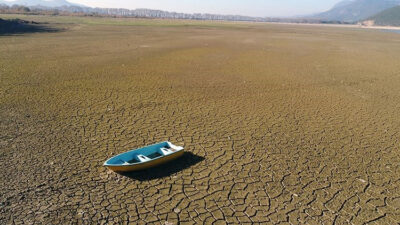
[119,152,205,181]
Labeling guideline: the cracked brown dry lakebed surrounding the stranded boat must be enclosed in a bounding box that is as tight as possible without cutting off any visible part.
[0,19,400,224]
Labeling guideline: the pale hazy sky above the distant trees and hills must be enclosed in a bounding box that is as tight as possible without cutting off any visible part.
[64,0,341,17]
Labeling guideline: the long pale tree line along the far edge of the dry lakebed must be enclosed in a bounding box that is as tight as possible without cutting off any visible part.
[0,4,356,24]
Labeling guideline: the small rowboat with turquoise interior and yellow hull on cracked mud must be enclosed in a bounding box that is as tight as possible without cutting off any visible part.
[104,141,184,172]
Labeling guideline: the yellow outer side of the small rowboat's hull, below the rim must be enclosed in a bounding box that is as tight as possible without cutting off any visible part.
[106,150,184,172]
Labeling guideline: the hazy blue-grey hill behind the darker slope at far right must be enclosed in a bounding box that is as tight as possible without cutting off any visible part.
[312,0,400,22]
